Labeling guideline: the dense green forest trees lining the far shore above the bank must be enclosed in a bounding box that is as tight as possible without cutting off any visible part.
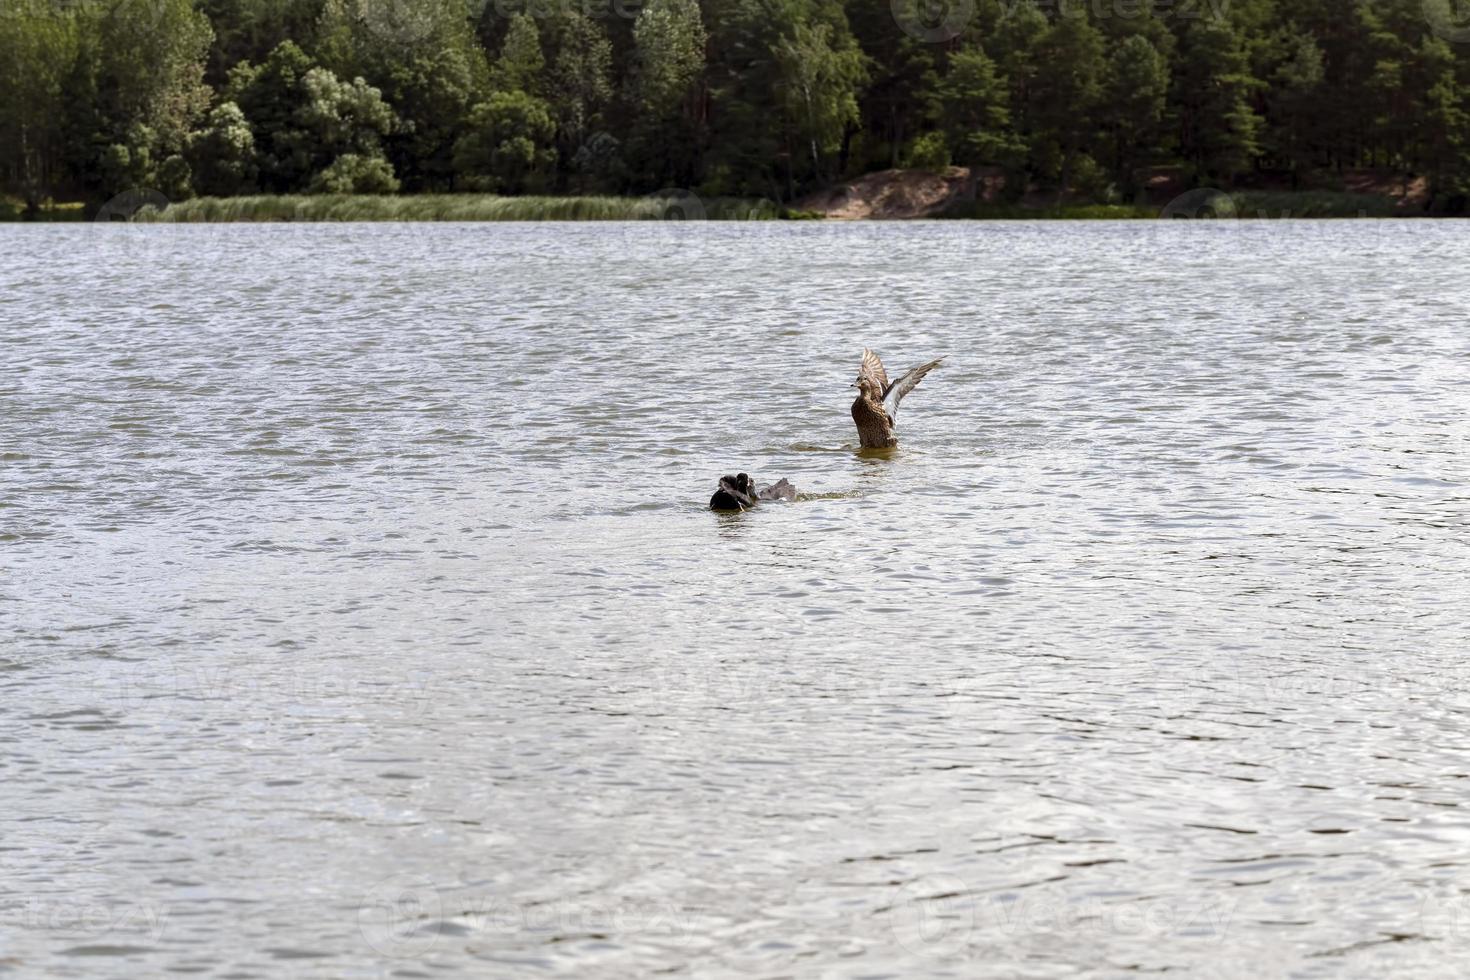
[0,0,1470,210]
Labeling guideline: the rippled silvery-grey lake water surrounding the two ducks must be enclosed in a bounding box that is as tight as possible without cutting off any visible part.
[0,220,1470,980]
